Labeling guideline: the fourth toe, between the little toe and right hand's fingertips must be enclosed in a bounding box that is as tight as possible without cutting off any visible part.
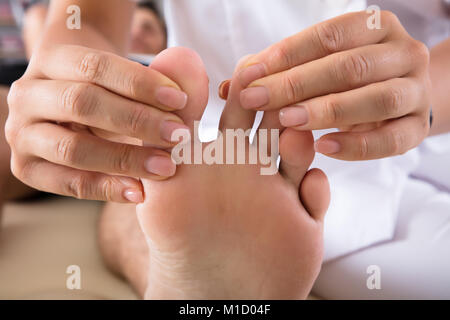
[280,129,315,189]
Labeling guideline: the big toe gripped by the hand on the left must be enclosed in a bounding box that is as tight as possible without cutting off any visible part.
[150,47,209,128]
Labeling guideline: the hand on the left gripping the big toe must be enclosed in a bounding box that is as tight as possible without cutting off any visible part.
[6,45,187,203]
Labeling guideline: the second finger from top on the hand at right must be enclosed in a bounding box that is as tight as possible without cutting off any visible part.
[240,42,415,111]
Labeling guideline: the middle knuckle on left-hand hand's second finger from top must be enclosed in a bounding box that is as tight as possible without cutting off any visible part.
[61,83,98,118]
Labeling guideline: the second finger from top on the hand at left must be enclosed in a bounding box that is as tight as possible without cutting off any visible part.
[18,80,188,148]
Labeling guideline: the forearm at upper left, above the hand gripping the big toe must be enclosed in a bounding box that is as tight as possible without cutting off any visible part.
[36,0,134,55]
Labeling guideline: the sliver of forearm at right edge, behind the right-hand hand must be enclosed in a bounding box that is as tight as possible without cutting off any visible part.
[430,39,450,135]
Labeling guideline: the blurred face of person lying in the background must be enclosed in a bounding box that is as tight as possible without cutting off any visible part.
[130,8,166,54]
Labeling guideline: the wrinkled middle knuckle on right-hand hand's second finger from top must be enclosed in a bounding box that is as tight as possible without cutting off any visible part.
[336,54,372,87]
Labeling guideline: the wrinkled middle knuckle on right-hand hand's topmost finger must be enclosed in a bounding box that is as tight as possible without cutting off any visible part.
[314,22,345,55]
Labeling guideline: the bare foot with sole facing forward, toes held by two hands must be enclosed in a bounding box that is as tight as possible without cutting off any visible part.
[137,48,329,299]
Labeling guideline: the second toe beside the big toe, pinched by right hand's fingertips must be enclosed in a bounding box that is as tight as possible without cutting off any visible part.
[219,55,257,130]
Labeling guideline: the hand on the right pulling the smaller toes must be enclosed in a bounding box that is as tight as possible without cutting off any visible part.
[240,12,431,160]
